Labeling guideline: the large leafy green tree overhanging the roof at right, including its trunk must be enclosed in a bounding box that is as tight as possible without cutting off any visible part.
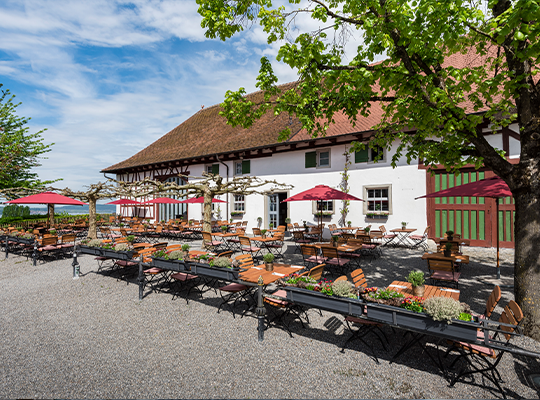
[198,0,540,340]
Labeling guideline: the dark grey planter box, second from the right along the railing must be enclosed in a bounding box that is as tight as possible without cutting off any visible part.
[283,286,366,317]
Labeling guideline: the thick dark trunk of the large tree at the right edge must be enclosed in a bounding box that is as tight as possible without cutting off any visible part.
[514,186,540,341]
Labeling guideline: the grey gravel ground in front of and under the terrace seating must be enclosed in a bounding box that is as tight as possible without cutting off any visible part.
[0,239,540,398]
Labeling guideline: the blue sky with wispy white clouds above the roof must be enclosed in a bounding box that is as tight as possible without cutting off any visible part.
[0,0,354,190]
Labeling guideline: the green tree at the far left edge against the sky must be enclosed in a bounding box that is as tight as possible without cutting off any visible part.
[0,84,56,189]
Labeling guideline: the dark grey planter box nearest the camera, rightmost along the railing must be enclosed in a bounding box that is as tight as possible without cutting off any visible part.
[367,303,481,342]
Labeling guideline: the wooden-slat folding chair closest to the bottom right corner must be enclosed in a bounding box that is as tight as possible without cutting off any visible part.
[446,300,523,398]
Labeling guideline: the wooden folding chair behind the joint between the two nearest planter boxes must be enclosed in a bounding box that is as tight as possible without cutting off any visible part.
[338,268,389,363]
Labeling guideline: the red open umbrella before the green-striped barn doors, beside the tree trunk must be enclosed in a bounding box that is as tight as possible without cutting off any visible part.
[417,176,512,279]
